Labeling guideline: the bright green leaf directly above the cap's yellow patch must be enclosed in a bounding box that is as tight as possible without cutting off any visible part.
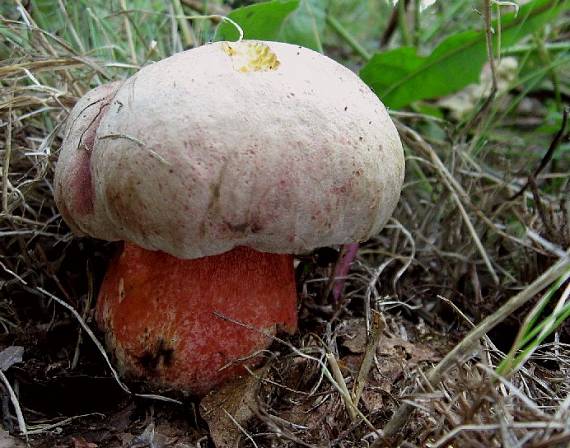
[214,0,301,40]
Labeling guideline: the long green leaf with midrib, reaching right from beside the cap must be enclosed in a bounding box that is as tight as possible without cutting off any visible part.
[360,0,568,109]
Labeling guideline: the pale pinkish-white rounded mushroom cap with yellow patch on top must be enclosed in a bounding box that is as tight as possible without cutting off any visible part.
[55,41,404,258]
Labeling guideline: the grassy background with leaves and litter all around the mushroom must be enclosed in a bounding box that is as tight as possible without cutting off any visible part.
[0,0,570,447]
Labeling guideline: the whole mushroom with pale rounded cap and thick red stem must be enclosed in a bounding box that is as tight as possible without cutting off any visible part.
[55,41,404,394]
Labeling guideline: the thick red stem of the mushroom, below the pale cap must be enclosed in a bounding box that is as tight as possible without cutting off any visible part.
[96,243,297,395]
